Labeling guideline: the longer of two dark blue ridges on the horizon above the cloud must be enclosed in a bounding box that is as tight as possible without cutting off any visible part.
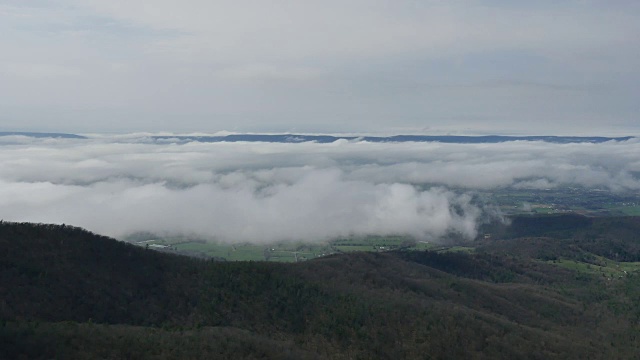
[151,134,634,144]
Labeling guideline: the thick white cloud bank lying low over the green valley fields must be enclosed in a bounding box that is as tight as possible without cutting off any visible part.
[0,137,640,242]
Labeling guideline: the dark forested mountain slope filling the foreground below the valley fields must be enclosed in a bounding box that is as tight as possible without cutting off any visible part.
[0,223,640,359]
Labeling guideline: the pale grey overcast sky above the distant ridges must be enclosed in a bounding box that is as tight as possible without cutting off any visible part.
[0,0,640,135]
